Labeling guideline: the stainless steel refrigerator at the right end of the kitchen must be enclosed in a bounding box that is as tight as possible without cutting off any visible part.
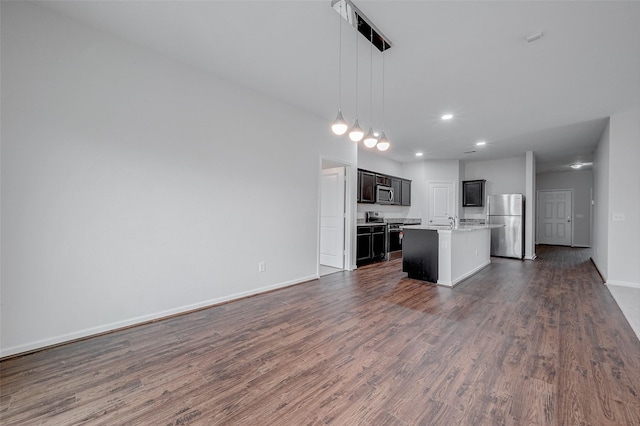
[487,194,524,259]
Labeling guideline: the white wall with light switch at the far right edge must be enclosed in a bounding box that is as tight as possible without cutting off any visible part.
[607,108,640,287]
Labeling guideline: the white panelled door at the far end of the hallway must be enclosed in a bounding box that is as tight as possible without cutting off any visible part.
[538,191,573,246]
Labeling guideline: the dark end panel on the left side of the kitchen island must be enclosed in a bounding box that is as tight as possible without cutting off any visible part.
[402,229,438,283]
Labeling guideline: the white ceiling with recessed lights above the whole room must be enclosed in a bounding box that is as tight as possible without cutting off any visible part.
[35,0,640,172]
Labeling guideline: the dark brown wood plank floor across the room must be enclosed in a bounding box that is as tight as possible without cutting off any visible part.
[0,247,640,425]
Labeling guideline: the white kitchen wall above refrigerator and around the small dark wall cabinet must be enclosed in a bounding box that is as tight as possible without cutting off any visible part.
[460,155,526,219]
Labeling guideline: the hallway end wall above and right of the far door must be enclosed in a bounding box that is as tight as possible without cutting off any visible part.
[536,170,593,247]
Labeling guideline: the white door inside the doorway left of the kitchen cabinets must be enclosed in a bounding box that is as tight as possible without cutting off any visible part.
[320,167,345,269]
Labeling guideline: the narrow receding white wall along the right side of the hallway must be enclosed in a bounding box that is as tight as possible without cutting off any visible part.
[591,122,611,280]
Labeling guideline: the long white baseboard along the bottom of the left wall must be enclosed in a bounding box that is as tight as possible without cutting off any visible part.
[0,274,318,358]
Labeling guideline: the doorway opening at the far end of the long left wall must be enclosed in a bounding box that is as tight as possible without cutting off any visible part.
[318,160,349,276]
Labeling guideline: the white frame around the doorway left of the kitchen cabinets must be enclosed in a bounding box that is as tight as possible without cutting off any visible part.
[316,156,357,277]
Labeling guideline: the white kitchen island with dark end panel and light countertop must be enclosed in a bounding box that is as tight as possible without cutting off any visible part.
[402,225,504,287]
